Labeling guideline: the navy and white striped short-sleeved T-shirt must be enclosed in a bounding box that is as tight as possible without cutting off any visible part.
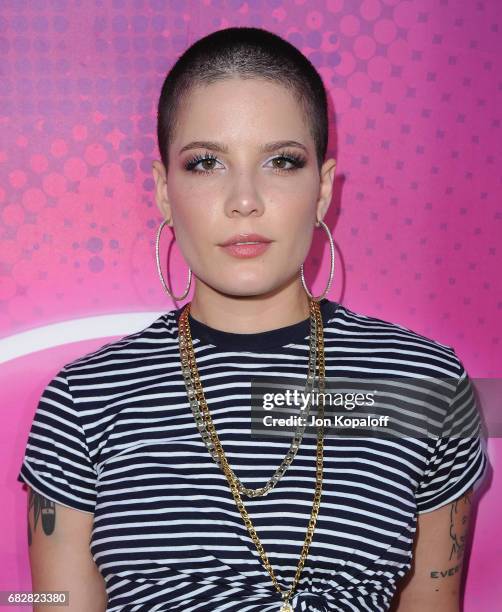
[18,299,487,612]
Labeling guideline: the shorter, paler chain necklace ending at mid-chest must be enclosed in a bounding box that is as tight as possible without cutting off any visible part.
[178,300,322,497]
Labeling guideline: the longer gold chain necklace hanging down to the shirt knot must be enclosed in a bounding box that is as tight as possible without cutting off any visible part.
[179,300,325,612]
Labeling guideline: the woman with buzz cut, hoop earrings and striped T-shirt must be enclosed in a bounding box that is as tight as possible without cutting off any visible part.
[19,28,486,612]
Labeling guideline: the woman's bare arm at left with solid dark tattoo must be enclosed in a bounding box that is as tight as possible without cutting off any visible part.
[28,487,107,612]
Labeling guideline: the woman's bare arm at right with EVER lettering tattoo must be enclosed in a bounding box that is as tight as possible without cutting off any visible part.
[392,489,472,612]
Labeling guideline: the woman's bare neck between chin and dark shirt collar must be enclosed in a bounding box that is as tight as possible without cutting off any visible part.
[186,279,310,334]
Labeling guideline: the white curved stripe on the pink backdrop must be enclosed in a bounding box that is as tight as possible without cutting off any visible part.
[0,311,164,363]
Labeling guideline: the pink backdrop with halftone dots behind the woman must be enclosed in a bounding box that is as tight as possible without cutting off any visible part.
[0,0,502,612]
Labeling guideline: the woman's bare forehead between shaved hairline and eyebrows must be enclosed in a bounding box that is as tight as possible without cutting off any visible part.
[175,77,310,145]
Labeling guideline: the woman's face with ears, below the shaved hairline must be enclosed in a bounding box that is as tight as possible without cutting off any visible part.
[153,78,336,296]
